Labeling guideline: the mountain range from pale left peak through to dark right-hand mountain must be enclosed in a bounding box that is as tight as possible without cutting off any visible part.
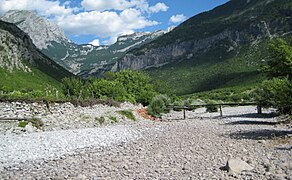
[1,0,292,94]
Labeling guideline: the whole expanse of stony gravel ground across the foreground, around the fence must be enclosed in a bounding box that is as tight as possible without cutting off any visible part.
[0,105,292,179]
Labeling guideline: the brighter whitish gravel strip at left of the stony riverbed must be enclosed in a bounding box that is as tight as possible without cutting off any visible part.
[0,126,139,166]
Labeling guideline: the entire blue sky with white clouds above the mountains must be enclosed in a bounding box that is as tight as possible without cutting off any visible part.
[0,0,228,46]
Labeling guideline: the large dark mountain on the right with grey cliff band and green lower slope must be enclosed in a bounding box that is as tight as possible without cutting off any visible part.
[109,0,292,94]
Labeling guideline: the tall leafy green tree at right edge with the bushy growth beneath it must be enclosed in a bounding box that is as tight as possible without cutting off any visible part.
[255,38,292,114]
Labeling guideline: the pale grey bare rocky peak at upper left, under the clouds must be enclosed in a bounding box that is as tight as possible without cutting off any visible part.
[0,10,69,49]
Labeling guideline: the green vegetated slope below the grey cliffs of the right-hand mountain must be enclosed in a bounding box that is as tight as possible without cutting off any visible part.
[147,41,267,95]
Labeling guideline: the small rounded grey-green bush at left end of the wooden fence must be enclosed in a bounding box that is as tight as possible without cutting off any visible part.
[147,94,170,117]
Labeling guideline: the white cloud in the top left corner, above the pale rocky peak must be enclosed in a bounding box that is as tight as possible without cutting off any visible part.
[0,0,73,16]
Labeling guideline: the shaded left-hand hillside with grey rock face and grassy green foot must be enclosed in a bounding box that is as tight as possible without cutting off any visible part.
[0,20,72,90]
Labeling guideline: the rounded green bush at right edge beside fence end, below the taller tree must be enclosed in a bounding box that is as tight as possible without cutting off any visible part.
[255,78,292,114]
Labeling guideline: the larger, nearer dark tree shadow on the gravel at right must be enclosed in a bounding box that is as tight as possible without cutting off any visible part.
[229,129,292,140]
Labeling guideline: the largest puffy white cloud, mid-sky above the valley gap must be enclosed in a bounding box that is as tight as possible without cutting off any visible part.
[57,8,158,38]
